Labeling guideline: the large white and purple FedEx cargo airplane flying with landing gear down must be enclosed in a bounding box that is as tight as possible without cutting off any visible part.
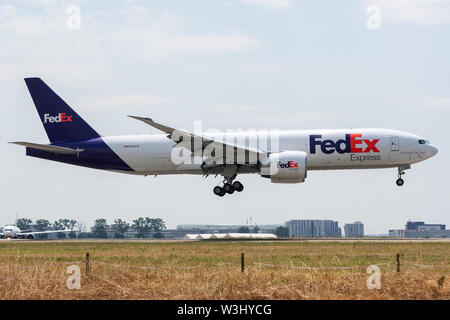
[13,78,438,197]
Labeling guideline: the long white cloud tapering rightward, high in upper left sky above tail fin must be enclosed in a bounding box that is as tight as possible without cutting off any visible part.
[0,1,259,63]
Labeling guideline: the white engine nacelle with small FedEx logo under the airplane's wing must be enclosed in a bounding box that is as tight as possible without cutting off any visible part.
[261,151,307,183]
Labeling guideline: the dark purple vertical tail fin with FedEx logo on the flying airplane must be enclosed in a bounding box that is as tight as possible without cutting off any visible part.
[25,78,100,143]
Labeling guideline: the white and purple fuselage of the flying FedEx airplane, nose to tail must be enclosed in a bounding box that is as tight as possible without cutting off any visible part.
[27,129,437,175]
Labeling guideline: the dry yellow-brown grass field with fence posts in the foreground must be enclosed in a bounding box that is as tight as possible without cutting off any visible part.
[0,241,450,299]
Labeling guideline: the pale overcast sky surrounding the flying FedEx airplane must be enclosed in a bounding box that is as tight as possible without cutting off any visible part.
[0,0,450,234]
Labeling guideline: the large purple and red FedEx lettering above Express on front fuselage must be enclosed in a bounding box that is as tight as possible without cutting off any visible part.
[309,133,380,154]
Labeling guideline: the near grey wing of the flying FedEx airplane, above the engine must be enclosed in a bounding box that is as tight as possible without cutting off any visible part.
[129,116,267,165]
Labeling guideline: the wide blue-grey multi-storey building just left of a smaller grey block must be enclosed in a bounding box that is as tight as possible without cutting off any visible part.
[286,220,341,238]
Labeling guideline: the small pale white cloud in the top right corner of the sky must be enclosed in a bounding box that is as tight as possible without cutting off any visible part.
[364,0,450,25]
